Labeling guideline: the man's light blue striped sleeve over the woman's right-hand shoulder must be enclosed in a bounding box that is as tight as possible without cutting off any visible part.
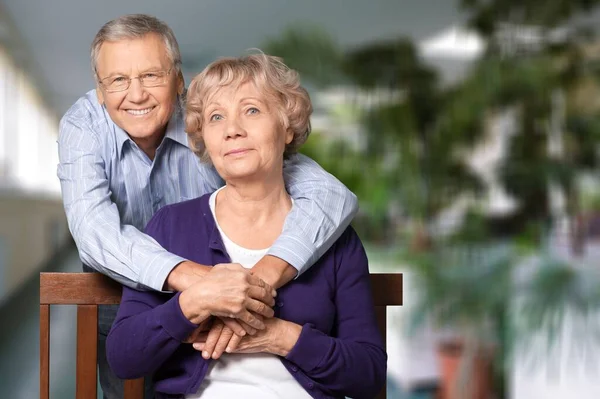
[268,154,358,275]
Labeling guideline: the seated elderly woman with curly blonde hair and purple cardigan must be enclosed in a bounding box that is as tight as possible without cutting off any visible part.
[107,54,387,398]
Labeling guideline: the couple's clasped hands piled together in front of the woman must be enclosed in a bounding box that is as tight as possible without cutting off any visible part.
[179,263,287,359]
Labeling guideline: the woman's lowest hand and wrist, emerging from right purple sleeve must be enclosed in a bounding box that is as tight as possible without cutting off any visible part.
[194,317,302,356]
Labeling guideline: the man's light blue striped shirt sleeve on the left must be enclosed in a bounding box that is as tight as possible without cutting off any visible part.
[57,118,185,290]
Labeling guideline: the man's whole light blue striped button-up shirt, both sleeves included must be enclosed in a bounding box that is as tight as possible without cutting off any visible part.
[58,90,358,290]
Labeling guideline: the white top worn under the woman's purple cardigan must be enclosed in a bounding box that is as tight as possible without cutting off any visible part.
[186,189,311,399]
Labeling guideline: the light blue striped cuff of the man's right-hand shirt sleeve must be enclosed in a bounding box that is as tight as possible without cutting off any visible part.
[267,234,319,278]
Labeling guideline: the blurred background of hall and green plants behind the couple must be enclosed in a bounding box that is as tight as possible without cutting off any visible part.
[0,0,600,399]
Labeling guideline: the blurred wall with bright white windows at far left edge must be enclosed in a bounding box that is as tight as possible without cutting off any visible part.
[0,13,68,304]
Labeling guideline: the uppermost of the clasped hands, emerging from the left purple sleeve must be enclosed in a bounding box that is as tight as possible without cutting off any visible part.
[179,263,276,330]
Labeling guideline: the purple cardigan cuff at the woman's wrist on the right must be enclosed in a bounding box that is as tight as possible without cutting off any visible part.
[285,324,333,373]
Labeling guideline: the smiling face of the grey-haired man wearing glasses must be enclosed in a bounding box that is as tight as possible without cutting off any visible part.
[96,34,183,149]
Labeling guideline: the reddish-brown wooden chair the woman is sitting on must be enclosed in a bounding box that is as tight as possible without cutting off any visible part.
[40,273,402,399]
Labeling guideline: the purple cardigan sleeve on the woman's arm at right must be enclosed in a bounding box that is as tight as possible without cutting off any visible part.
[286,228,387,398]
